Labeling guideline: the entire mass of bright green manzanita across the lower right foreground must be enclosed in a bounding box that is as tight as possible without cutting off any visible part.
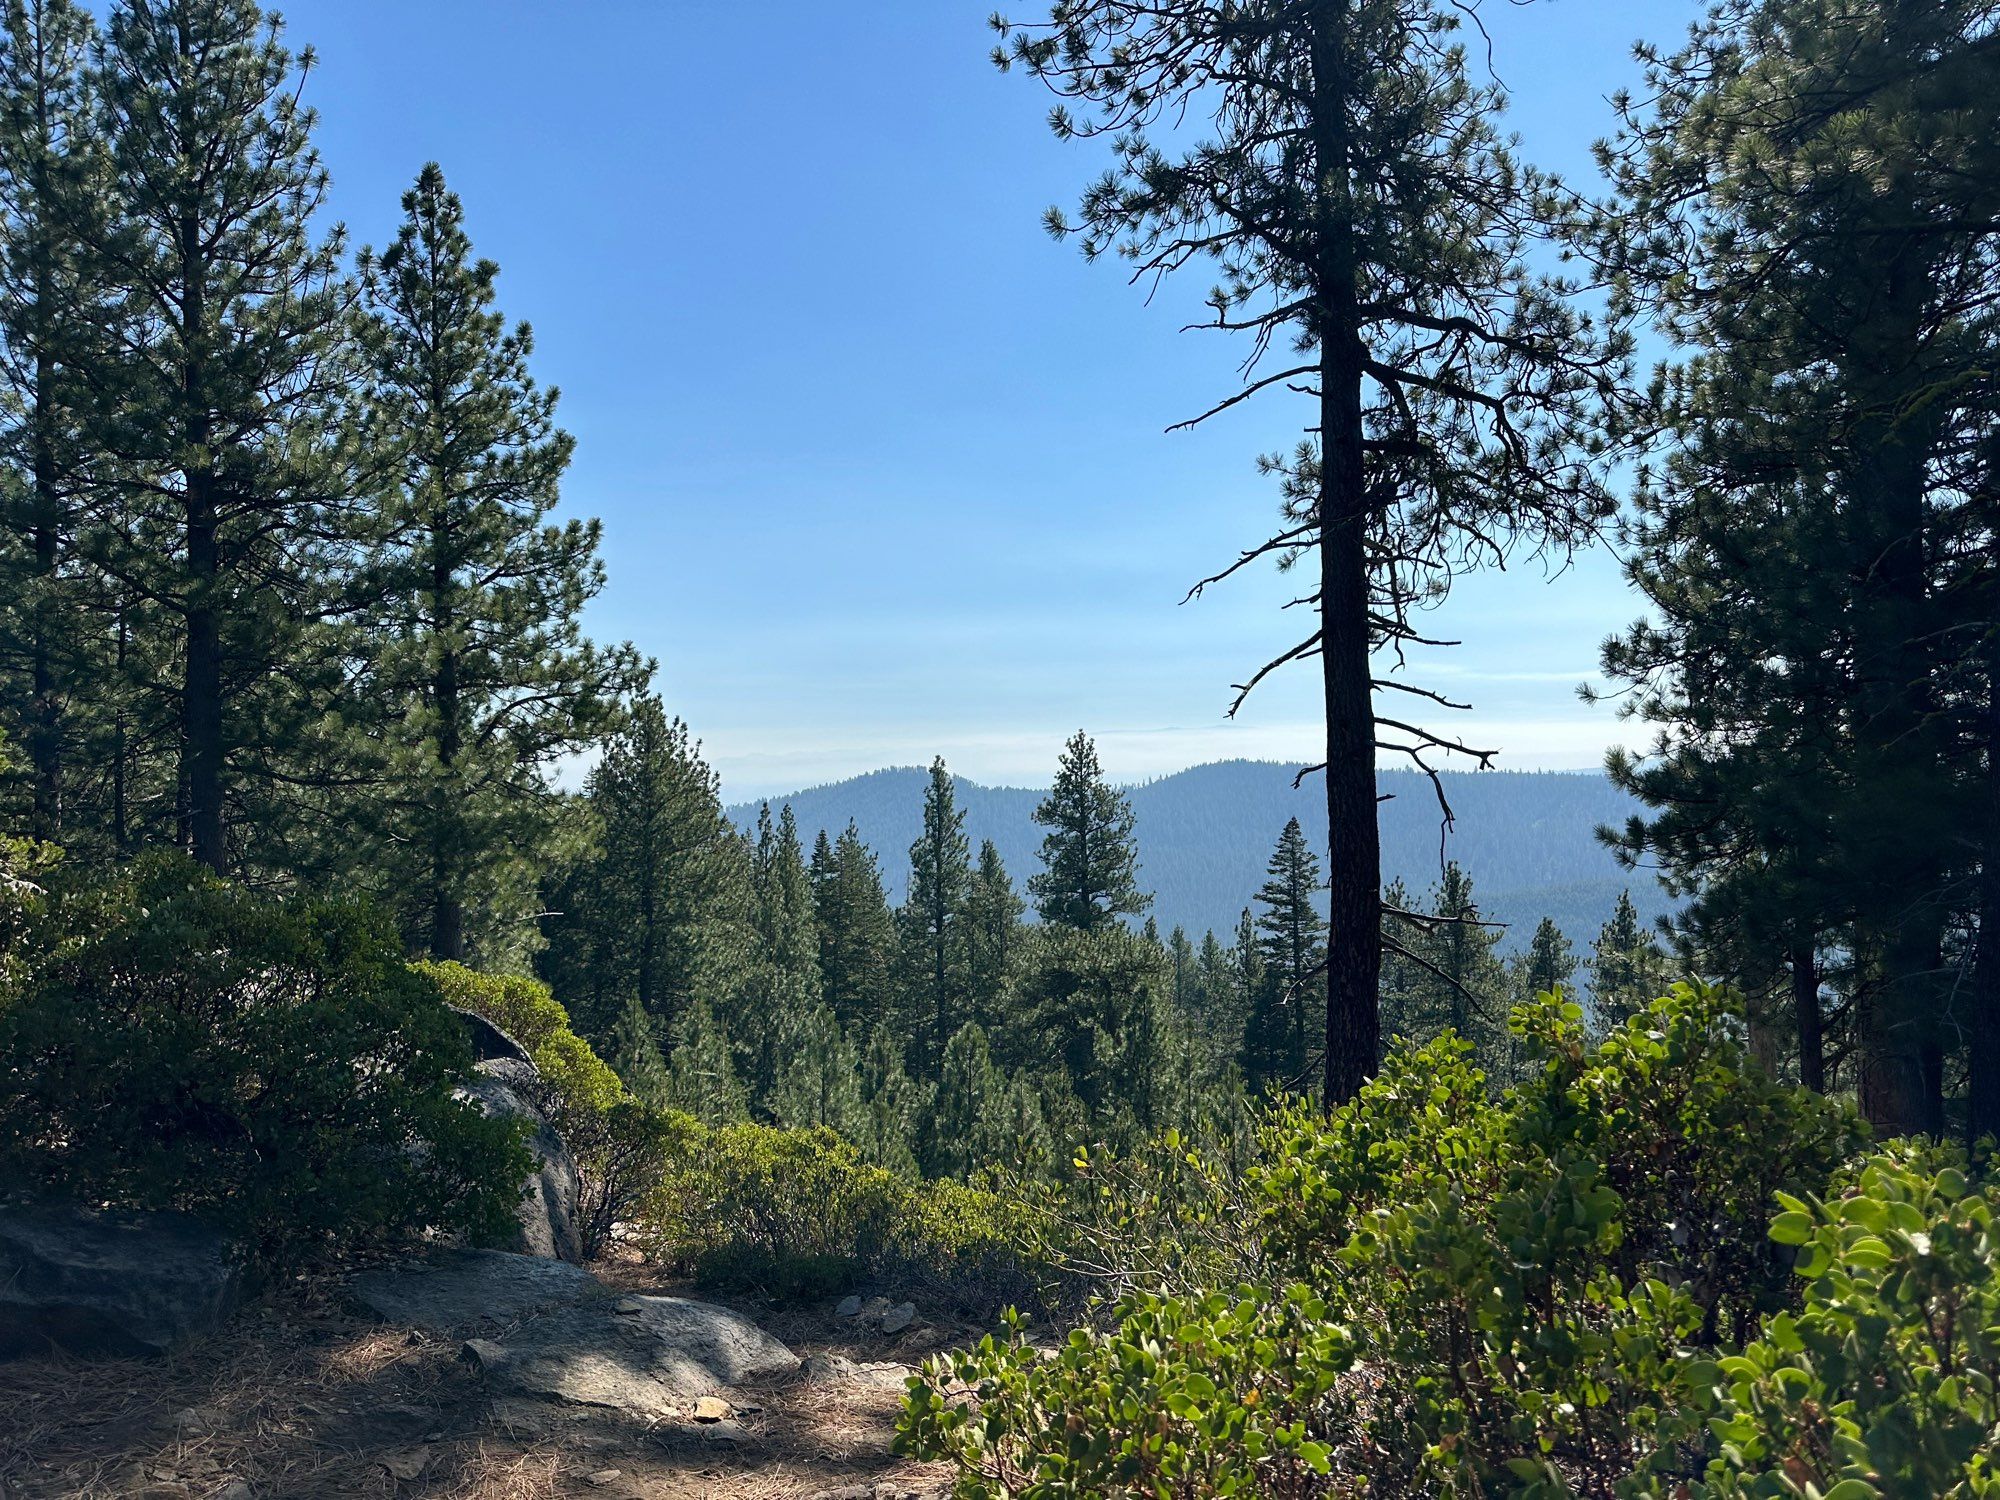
[898,984,2000,1500]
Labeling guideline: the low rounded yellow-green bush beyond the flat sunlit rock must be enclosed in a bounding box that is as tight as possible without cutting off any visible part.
[642,1116,1036,1310]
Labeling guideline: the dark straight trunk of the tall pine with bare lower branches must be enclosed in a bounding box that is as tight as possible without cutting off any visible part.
[1312,0,1382,1108]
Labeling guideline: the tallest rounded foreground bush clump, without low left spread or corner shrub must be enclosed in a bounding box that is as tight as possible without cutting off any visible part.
[1252,984,1862,1494]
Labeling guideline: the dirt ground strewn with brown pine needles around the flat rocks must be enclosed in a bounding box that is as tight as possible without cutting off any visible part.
[0,1264,972,1500]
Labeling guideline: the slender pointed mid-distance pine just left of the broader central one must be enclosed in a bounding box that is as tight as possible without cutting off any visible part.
[896,758,972,1080]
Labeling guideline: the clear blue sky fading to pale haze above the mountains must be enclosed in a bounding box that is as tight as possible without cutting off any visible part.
[284,0,1694,796]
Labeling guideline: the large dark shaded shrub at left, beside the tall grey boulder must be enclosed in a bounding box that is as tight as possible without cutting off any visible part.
[0,860,528,1262]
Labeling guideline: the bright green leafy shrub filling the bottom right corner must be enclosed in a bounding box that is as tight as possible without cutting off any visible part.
[1650,1146,2000,1500]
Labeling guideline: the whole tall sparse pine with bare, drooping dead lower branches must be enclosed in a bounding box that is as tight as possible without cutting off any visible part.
[996,0,1624,1104]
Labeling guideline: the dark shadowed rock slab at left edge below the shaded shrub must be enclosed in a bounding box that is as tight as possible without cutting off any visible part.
[0,1208,242,1358]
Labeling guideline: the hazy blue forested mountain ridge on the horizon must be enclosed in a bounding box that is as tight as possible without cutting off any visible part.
[728,760,1672,952]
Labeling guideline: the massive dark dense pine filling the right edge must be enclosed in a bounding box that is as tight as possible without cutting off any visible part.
[1604,0,2000,1134]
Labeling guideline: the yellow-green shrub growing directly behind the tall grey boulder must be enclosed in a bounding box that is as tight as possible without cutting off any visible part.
[412,960,694,1256]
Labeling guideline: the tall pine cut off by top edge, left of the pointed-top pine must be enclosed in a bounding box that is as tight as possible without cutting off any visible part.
[90,0,352,870]
